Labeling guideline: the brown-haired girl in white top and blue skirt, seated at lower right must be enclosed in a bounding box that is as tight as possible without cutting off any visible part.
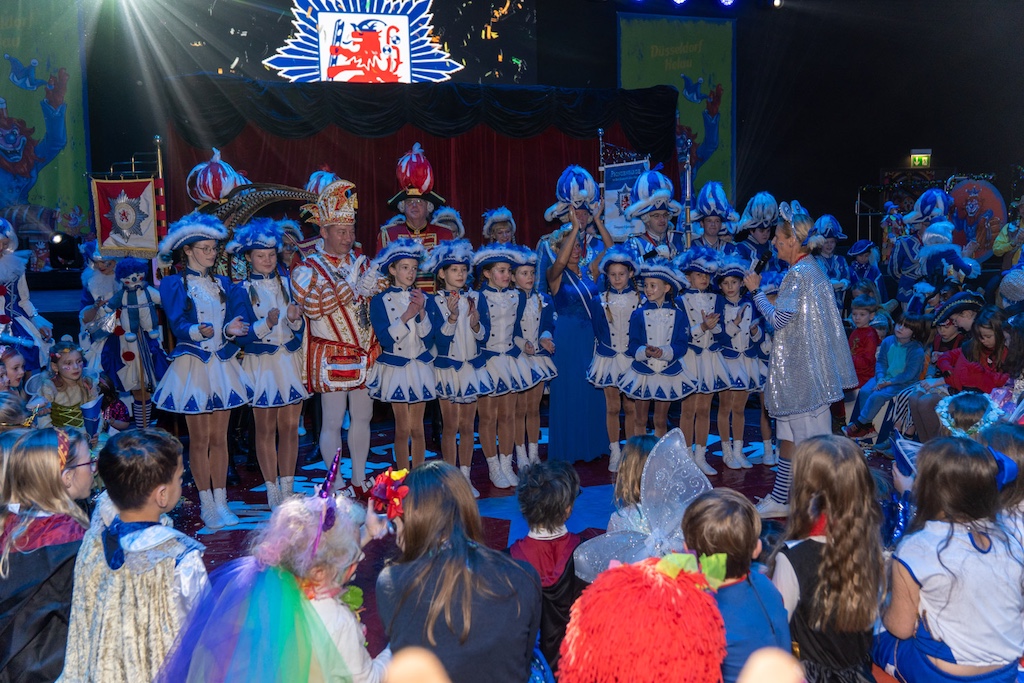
[872,437,1024,683]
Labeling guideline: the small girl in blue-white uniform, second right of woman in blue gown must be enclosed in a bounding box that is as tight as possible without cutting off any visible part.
[618,256,693,438]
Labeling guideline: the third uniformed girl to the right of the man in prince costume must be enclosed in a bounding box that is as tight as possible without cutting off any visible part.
[473,244,528,488]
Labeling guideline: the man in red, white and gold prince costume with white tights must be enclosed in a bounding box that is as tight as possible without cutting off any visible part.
[292,180,380,488]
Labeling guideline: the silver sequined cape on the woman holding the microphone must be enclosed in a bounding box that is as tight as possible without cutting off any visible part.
[758,258,857,418]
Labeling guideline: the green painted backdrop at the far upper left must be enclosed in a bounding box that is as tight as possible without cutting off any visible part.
[0,0,91,233]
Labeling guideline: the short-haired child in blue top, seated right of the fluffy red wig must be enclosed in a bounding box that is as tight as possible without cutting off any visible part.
[683,488,793,683]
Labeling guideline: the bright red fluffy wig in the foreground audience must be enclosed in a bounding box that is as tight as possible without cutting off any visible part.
[558,556,725,683]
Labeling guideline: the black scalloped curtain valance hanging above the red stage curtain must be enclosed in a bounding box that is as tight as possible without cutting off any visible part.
[167,74,678,163]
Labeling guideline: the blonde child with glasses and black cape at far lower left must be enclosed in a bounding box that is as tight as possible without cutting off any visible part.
[0,428,93,681]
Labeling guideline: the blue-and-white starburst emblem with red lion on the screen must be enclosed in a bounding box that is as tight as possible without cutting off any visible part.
[263,0,463,83]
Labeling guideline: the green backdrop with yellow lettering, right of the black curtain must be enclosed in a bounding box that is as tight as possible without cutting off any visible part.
[618,13,735,199]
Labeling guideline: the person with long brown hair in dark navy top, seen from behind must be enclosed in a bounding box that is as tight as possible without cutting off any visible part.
[377,461,541,683]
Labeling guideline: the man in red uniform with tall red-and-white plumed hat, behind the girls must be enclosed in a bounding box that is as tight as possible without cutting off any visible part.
[377,142,455,294]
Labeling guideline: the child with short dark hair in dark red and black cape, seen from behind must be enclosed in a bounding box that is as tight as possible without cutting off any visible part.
[509,460,585,671]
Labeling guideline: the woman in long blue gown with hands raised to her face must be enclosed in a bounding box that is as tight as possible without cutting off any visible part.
[546,206,608,461]
